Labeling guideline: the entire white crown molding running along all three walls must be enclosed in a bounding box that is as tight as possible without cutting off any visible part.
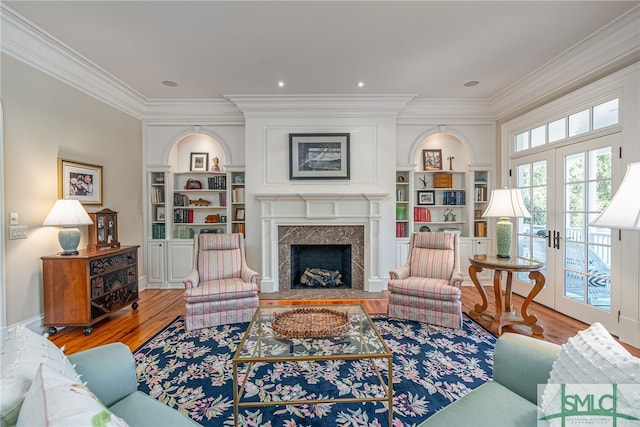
[0,2,640,124]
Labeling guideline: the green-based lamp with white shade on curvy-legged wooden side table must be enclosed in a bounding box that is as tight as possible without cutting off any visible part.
[482,188,531,258]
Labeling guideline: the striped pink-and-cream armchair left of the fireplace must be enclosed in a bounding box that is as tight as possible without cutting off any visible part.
[184,233,259,330]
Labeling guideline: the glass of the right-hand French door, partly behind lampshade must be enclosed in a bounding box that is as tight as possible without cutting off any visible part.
[564,147,611,311]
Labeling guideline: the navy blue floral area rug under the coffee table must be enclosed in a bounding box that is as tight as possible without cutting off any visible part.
[134,316,496,427]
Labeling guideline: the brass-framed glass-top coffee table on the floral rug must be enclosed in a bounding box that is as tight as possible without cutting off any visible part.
[233,305,393,427]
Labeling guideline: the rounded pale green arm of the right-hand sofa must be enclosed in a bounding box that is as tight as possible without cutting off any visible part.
[493,333,560,404]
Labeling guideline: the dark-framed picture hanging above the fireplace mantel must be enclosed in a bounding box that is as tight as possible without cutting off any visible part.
[289,133,350,179]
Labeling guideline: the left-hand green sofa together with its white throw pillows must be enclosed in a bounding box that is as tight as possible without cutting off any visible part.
[0,325,199,427]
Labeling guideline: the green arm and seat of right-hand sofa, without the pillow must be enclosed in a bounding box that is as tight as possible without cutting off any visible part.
[420,333,561,427]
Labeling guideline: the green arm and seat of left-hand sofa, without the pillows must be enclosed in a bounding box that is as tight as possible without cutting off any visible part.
[69,343,200,427]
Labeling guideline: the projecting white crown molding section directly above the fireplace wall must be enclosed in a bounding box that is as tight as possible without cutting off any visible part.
[224,94,416,117]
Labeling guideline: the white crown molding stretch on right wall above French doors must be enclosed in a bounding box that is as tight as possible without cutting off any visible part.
[490,6,640,117]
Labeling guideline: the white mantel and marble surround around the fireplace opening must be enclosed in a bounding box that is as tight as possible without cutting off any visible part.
[256,193,389,292]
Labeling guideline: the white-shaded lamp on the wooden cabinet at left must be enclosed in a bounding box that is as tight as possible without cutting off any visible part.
[43,199,93,255]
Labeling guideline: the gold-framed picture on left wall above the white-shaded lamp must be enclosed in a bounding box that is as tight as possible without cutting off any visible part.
[58,158,102,205]
